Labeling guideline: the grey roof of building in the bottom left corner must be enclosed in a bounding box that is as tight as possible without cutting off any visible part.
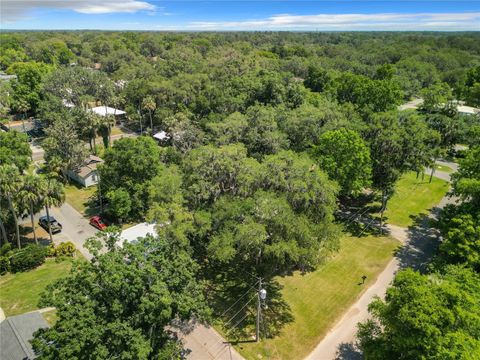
[0,312,48,360]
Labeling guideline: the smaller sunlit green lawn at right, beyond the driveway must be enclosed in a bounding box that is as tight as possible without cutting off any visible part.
[378,172,449,227]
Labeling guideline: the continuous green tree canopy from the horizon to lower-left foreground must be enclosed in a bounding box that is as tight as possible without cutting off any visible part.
[0,32,480,359]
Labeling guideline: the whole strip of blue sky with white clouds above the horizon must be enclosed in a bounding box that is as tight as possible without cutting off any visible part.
[0,0,480,31]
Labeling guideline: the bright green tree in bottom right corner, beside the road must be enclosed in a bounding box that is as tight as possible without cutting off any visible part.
[357,266,480,360]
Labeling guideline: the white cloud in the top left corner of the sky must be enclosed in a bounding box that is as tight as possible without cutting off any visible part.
[1,0,156,22]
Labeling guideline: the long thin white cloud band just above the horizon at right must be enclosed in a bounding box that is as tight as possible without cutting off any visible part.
[179,12,480,31]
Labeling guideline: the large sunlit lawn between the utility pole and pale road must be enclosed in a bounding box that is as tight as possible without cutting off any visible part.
[237,236,399,360]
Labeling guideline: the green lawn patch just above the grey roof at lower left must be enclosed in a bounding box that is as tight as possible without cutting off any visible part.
[0,259,72,316]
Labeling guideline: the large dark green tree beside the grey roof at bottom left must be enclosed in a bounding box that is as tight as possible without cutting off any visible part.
[32,233,209,360]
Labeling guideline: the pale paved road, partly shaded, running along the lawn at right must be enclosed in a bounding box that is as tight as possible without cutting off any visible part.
[306,163,457,360]
